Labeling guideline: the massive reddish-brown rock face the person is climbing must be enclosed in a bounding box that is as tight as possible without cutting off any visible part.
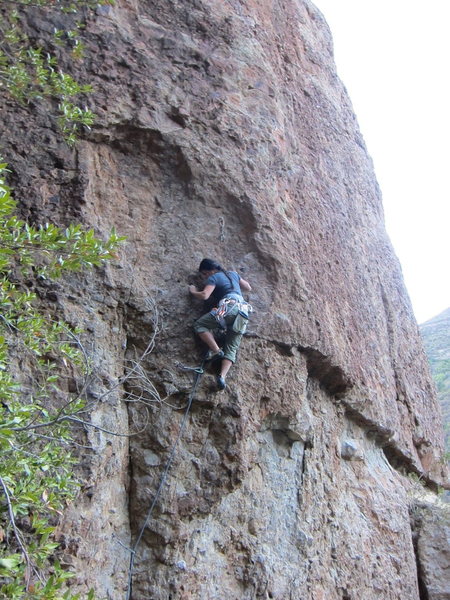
[3,0,444,600]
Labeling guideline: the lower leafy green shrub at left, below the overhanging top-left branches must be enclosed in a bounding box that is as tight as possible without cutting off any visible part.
[0,164,123,600]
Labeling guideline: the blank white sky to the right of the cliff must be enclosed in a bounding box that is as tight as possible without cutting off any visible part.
[313,0,450,323]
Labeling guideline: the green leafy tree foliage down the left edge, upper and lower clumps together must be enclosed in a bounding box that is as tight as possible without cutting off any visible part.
[0,0,123,600]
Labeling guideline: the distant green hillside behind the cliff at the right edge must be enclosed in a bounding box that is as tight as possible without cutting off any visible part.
[419,308,450,452]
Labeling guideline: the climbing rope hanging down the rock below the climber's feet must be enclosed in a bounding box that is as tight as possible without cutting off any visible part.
[126,352,208,600]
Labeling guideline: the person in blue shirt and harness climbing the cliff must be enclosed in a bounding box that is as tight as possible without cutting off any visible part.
[189,258,252,390]
